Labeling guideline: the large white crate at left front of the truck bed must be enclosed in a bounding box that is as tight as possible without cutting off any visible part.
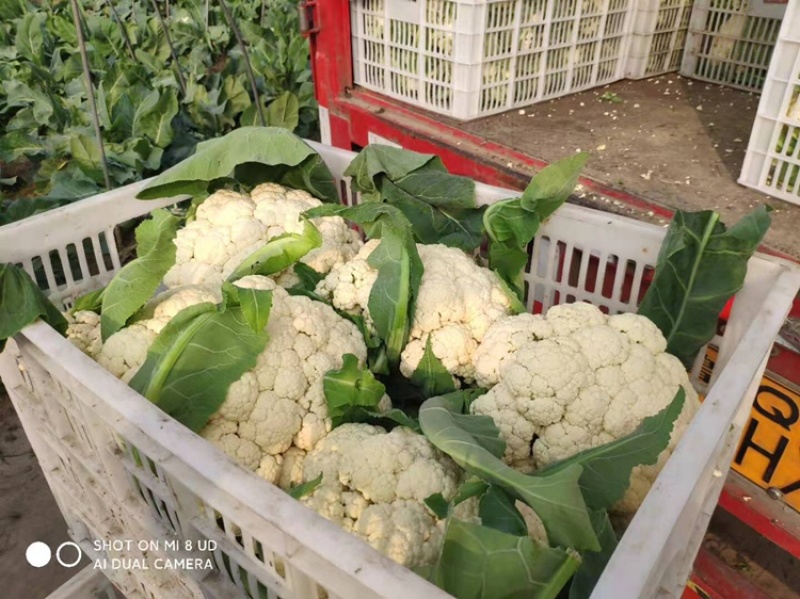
[350,0,632,119]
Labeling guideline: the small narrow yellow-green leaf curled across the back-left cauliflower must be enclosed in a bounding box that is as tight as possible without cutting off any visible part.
[228,220,322,281]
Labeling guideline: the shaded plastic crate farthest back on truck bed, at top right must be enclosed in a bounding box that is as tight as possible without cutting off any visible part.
[680,0,786,92]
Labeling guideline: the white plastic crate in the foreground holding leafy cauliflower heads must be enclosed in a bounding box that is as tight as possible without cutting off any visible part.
[0,144,800,599]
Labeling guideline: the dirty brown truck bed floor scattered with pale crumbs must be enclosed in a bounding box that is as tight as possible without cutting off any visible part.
[456,73,800,257]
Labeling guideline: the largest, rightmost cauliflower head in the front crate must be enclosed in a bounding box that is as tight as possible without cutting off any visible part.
[471,303,699,513]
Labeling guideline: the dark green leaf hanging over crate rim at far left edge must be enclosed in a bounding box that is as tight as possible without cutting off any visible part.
[0,264,67,351]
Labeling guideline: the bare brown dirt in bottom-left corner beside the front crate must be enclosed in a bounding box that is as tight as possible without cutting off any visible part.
[0,387,79,599]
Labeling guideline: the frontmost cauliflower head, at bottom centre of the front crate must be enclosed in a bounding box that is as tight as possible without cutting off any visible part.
[302,424,463,568]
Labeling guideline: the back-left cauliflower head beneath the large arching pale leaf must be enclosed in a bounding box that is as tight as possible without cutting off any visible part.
[164,188,362,288]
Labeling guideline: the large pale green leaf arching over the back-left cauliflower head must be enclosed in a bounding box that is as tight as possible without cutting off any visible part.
[137,127,339,202]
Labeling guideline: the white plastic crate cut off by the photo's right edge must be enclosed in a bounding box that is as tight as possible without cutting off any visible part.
[739,0,800,204]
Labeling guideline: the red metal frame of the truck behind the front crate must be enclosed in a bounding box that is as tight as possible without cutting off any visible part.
[310,0,800,599]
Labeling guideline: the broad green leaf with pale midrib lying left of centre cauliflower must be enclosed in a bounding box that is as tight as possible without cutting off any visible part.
[130,291,272,431]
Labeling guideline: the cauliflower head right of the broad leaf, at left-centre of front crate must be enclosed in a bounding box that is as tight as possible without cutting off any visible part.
[200,276,367,487]
